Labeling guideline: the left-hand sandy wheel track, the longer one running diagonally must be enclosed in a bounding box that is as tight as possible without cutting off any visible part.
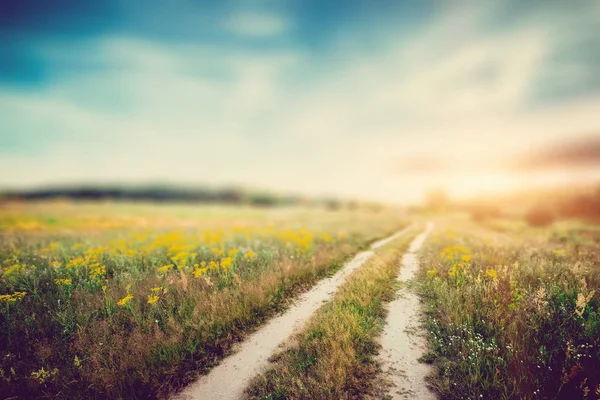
[175,227,410,400]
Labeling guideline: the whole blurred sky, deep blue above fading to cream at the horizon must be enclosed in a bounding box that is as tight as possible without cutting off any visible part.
[0,0,600,202]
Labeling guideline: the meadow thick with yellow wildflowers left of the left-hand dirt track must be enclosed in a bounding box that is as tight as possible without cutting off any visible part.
[0,203,402,399]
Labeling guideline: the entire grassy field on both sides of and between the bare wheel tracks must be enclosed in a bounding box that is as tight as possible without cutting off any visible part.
[0,201,600,399]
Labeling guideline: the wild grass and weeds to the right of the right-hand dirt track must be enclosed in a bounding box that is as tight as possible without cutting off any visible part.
[418,219,600,399]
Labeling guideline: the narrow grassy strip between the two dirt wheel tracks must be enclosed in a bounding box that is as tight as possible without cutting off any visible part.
[247,227,409,399]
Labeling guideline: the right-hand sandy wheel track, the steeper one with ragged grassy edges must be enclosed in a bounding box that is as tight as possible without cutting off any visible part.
[379,223,436,400]
